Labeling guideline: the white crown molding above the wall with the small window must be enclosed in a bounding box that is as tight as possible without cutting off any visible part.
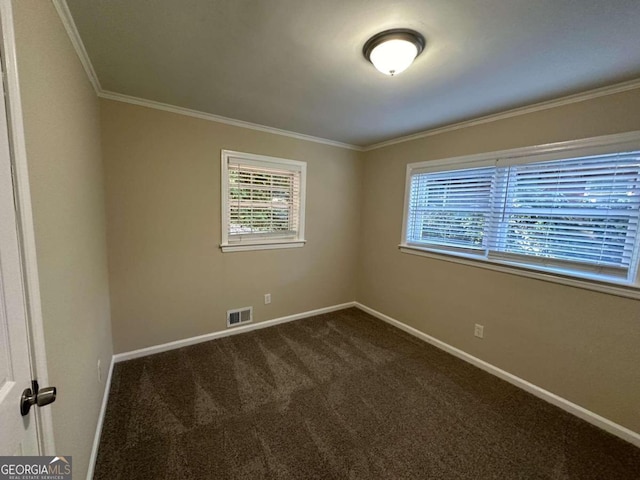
[98,90,363,152]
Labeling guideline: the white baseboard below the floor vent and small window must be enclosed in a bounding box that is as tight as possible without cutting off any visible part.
[113,302,356,363]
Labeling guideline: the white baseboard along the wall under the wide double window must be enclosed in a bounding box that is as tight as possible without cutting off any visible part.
[355,302,640,447]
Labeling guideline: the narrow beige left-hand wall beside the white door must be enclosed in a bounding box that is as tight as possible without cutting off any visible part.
[13,0,112,472]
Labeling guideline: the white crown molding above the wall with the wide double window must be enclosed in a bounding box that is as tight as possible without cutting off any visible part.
[362,78,640,152]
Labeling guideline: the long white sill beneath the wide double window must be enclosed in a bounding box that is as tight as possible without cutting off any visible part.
[399,244,640,299]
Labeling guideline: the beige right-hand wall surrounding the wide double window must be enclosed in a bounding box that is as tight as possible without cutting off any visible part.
[357,90,640,432]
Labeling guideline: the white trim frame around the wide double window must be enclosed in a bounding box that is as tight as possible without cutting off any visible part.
[399,131,640,299]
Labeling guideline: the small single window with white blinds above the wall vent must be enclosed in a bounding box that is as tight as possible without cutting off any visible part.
[221,150,306,252]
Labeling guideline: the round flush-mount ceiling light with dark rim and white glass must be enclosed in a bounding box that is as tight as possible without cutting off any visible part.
[362,28,426,77]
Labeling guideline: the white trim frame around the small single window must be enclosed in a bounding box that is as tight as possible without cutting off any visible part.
[220,150,307,253]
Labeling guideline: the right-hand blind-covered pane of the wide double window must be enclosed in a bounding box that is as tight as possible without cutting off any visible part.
[493,152,640,272]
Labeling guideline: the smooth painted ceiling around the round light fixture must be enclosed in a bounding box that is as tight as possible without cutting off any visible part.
[67,0,640,146]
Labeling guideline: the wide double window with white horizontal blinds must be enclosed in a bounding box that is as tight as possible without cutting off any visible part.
[401,134,640,294]
